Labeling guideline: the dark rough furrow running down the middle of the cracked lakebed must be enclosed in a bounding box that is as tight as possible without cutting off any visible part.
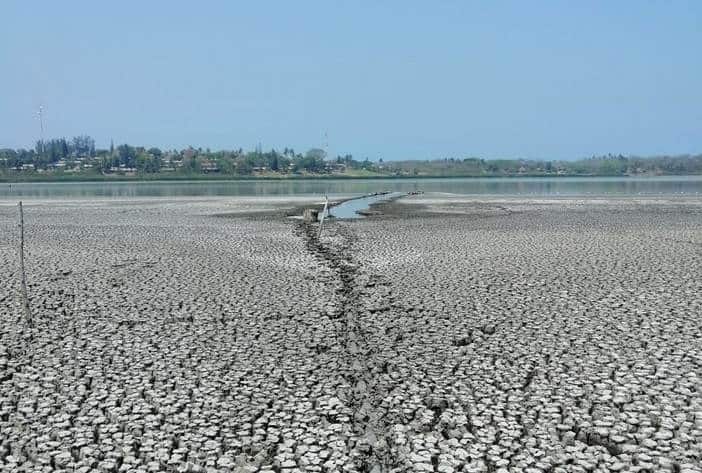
[299,219,402,473]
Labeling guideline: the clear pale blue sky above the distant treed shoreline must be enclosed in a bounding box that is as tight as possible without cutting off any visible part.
[0,0,702,159]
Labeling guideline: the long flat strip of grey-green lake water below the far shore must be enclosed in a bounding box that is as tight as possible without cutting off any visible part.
[0,176,702,200]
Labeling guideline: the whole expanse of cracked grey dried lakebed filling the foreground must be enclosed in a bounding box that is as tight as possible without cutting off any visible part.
[0,196,702,473]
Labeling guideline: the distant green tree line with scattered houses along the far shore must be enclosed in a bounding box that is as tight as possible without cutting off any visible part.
[0,135,702,176]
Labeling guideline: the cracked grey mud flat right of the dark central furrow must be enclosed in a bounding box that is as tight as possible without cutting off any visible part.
[345,198,702,471]
